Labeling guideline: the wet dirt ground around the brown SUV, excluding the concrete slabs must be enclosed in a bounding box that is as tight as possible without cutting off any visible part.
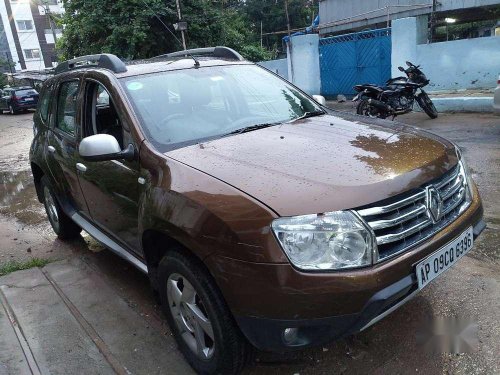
[0,109,500,374]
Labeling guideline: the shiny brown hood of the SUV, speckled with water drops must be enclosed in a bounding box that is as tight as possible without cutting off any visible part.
[166,113,457,216]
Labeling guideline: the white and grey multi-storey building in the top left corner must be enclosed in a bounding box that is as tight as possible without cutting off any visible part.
[0,0,64,72]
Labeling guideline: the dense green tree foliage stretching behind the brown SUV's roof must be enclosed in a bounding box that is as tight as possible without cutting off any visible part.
[57,0,310,61]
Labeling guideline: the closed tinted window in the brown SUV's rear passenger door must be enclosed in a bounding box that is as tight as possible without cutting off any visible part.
[56,81,79,135]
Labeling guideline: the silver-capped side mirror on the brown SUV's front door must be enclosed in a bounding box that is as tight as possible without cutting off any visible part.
[78,134,135,161]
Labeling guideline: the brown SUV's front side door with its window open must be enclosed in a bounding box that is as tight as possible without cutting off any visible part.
[79,79,142,254]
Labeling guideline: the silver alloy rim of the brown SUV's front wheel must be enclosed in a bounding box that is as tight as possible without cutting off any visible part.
[167,273,215,360]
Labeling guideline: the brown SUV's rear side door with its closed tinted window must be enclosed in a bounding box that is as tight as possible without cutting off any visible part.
[45,79,88,216]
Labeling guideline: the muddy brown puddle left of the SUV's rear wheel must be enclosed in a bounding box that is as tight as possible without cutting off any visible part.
[0,171,47,226]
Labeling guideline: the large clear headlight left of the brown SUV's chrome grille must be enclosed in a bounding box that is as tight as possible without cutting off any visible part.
[272,211,377,270]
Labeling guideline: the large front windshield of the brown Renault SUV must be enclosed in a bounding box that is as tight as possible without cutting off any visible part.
[122,65,322,152]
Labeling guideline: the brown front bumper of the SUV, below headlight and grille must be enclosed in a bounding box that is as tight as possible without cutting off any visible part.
[205,190,485,351]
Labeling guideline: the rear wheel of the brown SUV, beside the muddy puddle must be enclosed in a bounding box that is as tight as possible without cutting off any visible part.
[40,176,82,240]
